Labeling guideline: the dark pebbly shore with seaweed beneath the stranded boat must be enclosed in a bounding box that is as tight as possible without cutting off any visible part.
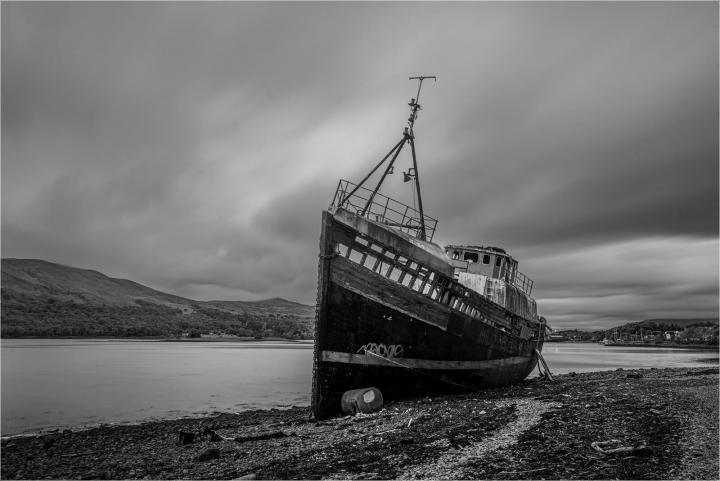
[1,367,719,479]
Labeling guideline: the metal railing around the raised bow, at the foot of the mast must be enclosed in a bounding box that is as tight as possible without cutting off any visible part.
[330,179,437,241]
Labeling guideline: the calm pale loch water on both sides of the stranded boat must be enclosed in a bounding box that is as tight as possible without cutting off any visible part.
[0,339,717,435]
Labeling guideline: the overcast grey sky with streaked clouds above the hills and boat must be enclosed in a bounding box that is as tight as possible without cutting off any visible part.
[0,2,719,329]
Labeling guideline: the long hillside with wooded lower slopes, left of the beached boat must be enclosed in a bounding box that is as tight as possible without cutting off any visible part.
[0,259,315,339]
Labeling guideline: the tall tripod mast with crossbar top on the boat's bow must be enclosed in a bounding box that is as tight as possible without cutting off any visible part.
[340,75,437,240]
